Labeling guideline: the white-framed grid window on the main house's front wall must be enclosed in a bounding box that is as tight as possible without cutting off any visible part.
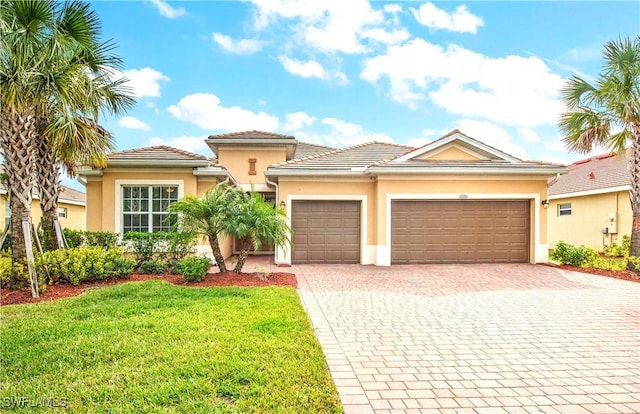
[122,185,178,233]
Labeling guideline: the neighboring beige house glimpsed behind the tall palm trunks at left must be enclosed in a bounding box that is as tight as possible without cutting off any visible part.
[0,184,86,234]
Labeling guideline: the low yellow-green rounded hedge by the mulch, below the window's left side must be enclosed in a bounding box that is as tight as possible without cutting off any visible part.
[39,246,135,285]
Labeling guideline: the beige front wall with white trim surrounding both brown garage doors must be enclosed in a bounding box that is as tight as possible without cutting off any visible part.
[278,175,548,265]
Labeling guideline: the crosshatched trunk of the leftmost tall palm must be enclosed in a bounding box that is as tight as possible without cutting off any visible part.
[0,108,37,296]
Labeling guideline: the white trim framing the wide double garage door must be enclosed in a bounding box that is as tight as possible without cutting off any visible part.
[376,193,548,266]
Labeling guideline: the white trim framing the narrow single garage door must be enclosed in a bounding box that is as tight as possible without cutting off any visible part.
[277,194,376,264]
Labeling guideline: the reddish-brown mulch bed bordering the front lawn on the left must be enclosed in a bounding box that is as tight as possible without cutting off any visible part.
[0,272,298,306]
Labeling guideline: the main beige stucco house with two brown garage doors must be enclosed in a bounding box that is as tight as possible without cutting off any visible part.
[78,130,565,266]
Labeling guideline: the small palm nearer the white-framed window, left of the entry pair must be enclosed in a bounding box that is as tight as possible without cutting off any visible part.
[169,183,242,272]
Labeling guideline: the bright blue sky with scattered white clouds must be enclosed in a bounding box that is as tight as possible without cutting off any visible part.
[69,0,640,188]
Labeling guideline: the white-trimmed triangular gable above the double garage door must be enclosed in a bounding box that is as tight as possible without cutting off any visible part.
[394,129,522,163]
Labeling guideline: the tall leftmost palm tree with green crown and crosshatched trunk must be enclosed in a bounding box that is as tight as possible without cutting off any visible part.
[0,0,133,295]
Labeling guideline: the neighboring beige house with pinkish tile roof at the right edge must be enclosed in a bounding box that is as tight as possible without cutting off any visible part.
[548,151,633,251]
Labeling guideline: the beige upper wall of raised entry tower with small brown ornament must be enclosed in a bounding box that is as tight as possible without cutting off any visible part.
[218,146,286,184]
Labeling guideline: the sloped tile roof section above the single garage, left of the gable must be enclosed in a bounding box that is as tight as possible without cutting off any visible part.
[269,142,414,171]
